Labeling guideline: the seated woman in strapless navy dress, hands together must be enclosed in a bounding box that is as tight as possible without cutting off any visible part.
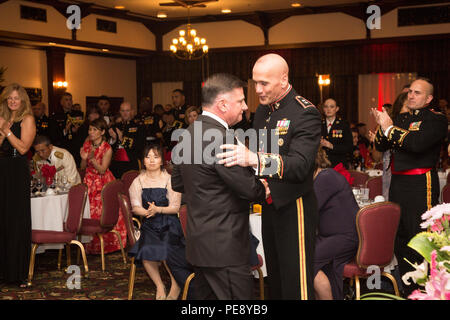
[128,144,185,300]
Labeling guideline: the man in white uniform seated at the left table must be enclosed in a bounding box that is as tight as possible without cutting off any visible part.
[33,136,81,185]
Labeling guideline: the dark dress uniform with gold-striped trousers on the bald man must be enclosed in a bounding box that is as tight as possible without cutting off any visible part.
[253,88,321,299]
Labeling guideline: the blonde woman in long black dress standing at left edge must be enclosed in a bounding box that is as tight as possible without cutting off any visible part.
[0,84,36,287]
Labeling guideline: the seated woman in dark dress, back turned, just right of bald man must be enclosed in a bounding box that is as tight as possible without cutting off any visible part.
[314,148,359,300]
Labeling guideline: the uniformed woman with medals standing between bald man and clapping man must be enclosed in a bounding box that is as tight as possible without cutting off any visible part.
[320,99,353,169]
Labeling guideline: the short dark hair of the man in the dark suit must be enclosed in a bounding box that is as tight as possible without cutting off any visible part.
[202,73,247,107]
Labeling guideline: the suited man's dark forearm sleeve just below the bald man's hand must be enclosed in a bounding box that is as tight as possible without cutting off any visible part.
[214,164,266,202]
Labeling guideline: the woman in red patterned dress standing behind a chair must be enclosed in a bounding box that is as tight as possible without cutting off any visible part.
[80,118,127,254]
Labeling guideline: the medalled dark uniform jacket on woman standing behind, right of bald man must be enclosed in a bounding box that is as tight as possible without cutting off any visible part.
[322,117,353,168]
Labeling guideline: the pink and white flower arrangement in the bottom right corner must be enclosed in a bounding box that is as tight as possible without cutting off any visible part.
[402,203,450,300]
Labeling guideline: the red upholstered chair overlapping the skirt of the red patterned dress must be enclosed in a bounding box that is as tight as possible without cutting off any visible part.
[79,179,127,271]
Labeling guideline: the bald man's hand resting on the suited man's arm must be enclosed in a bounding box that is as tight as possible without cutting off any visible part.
[216,140,258,168]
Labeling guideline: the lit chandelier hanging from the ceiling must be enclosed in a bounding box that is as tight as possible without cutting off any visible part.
[170,7,208,60]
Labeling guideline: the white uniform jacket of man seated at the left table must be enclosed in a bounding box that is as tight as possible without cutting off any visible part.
[33,146,81,185]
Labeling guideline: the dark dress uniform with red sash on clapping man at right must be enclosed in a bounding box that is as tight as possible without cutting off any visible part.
[375,108,447,286]
